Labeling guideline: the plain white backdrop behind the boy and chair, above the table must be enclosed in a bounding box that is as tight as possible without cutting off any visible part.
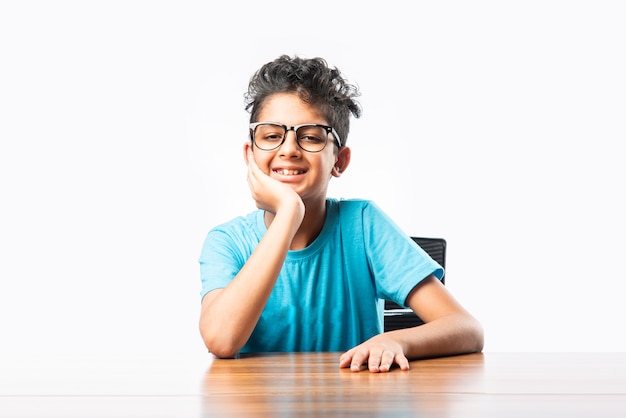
[0,0,626,356]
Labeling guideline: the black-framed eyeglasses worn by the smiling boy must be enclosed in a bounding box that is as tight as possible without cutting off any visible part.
[250,122,341,152]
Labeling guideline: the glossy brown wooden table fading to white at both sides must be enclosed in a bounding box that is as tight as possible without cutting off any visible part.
[0,353,626,418]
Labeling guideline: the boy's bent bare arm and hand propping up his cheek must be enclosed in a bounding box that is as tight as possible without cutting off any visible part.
[199,145,304,357]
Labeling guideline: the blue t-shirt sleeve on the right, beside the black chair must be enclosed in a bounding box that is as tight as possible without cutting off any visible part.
[363,202,444,305]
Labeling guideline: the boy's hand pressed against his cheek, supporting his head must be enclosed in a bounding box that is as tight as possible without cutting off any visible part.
[246,146,302,214]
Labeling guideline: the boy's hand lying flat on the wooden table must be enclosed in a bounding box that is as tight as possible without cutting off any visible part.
[339,333,409,373]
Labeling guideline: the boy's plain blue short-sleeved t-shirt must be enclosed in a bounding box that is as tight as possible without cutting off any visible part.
[200,198,444,352]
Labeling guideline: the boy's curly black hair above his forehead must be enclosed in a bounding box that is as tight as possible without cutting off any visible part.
[244,55,361,145]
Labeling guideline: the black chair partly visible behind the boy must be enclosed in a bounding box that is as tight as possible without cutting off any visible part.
[385,237,446,331]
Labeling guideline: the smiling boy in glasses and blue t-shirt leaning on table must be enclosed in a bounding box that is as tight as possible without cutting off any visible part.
[199,55,483,372]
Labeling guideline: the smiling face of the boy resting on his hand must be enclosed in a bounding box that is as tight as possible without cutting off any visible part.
[245,93,350,207]
